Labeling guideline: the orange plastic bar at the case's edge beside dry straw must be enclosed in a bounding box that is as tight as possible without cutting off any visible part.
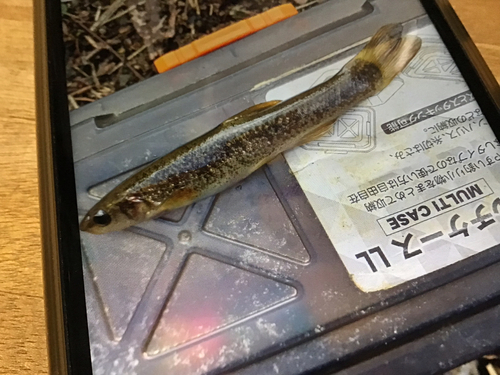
[154,4,298,73]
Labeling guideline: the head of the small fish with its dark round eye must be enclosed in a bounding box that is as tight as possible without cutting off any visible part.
[80,196,151,234]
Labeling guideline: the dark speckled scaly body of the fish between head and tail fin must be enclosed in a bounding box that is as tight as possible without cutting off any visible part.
[130,61,381,203]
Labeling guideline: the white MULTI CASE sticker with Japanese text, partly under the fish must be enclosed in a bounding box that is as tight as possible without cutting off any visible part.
[266,20,500,292]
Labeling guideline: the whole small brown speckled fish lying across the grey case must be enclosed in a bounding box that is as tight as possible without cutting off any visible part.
[80,24,421,234]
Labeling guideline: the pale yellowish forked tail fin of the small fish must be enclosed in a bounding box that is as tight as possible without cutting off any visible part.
[355,24,422,89]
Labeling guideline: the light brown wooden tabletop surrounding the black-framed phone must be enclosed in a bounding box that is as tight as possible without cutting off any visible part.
[0,0,500,375]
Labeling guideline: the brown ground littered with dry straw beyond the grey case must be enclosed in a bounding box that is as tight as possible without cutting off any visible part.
[61,0,318,109]
